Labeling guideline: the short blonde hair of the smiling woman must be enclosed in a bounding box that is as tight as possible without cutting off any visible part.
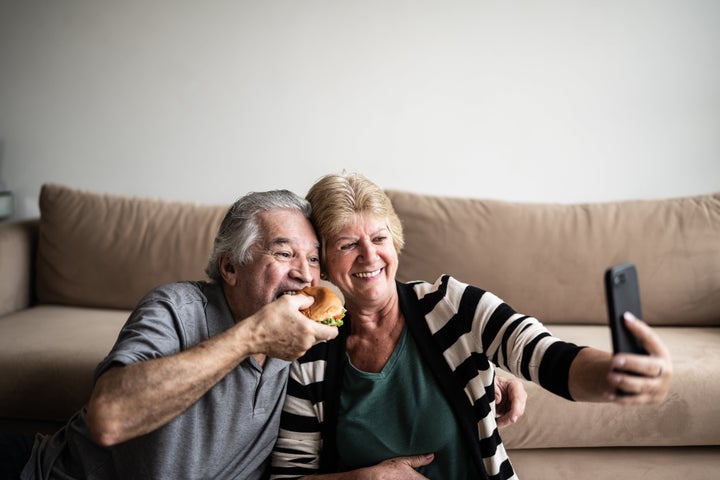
[306,172,405,264]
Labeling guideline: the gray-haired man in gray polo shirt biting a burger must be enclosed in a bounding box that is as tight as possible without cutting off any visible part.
[22,191,337,479]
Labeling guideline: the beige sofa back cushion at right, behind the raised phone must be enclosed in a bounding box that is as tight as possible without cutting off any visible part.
[387,190,720,326]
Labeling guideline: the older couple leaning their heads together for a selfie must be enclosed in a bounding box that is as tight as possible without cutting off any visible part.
[15,174,672,479]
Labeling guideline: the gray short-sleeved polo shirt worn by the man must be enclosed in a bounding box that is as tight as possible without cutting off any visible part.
[22,282,289,479]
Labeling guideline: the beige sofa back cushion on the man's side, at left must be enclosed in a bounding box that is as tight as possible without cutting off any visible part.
[37,184,228,309]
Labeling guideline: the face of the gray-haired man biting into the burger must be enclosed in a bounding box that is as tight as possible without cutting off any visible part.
[221,210,320,320]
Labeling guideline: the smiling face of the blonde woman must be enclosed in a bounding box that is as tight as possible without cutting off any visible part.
[325,214,398,308]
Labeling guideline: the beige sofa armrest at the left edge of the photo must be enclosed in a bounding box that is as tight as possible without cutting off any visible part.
[0,219,39,316]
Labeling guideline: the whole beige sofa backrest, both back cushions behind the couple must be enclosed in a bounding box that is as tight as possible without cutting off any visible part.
[36,184,720,325]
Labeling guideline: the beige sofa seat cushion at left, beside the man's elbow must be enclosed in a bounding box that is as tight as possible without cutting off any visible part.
[0,305,129,422]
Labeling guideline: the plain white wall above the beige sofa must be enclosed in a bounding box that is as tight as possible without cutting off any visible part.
[0,0,720,217]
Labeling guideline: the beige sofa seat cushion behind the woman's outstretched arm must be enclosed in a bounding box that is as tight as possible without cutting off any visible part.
[500,325,720,448]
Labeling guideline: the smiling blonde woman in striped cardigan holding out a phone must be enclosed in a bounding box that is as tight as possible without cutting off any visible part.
[272,174,672,479]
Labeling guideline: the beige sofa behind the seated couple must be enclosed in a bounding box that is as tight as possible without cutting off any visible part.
[0,185,720,479]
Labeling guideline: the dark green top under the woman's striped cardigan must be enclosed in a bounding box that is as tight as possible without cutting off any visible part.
[337,328,478,480]
